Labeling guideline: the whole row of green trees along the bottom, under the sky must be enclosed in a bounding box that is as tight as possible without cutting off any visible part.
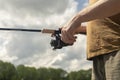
[0,61,91,80]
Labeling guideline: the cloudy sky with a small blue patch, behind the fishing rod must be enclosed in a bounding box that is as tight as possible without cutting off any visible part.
[0,0,92,71]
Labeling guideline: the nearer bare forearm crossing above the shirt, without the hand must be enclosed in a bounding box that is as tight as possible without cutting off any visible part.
[70,0,120,29]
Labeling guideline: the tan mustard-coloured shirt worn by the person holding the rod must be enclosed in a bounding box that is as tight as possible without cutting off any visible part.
[87,0,120,59]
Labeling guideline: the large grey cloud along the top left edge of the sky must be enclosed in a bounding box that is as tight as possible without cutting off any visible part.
[0,0,73,16]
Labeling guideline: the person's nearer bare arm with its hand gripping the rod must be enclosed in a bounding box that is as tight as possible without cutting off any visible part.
[62,0,120,43]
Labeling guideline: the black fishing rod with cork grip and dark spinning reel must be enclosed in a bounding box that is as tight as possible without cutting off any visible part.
[0,28,70,50]
